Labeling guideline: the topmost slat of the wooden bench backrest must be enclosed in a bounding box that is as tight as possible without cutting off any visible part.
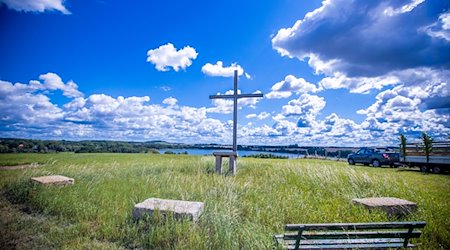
[285,221,426,231]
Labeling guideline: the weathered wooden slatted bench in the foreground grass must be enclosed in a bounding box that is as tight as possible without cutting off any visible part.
[274,221,426,249]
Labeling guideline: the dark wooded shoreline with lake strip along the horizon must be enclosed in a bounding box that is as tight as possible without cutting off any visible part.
[0,138,386,158]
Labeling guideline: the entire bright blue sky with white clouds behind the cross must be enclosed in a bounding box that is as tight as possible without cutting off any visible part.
[0,0,450,146]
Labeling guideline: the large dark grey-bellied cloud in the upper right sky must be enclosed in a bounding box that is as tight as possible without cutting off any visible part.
[272,0,450,108]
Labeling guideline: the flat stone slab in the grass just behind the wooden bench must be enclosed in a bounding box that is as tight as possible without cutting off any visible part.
[352,197,417,215]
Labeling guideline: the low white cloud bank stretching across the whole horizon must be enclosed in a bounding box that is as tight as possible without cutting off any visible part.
[0,73,450,146]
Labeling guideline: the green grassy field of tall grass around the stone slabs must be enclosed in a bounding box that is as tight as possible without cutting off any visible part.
[0,154,450,249]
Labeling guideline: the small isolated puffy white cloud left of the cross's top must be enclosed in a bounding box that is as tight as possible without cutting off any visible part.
[147,43,198,71]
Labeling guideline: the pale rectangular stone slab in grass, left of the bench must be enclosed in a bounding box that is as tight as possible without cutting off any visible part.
[133,198,204,222]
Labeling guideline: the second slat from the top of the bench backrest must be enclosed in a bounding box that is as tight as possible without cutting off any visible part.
[284,231,422,240]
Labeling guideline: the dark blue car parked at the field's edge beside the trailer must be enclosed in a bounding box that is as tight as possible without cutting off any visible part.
[347,147,399,167]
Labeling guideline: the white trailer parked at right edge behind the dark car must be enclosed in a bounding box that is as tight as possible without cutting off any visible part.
[400,141,450,174]
